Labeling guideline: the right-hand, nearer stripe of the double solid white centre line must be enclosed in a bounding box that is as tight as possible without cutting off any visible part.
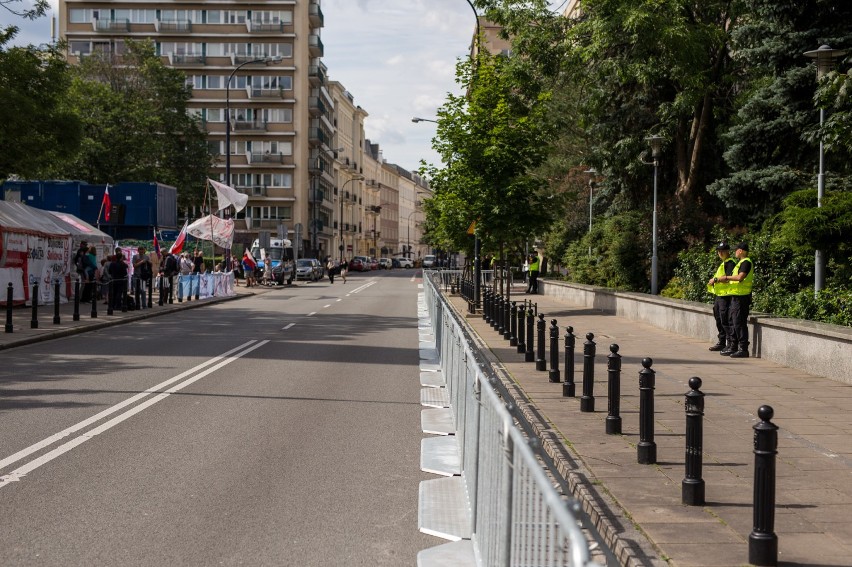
[0,340,269,488]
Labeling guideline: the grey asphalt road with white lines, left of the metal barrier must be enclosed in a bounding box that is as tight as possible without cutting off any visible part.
[0,270,441,566]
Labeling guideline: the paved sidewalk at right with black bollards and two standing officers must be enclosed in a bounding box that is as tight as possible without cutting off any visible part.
[451,294,852,566]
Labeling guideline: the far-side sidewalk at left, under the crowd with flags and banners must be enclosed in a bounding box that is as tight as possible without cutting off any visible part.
[0,285,274,351]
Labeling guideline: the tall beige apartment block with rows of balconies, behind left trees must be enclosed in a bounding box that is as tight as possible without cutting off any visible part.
[59,0,332,256]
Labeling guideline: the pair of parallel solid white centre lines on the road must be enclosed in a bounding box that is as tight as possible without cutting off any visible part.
[0,340,269,488]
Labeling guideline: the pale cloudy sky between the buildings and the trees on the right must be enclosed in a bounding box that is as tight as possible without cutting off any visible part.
[10,0,564,171]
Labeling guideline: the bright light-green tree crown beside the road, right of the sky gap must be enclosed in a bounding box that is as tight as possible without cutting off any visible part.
[426,48,552,260]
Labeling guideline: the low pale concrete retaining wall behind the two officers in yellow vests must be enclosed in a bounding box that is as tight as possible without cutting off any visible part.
[539,280,852,384]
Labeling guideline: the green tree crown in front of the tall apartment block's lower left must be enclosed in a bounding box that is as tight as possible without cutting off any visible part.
[57,41,213,208]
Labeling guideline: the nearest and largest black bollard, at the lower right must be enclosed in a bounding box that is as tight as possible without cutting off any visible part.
[748,406,778,566]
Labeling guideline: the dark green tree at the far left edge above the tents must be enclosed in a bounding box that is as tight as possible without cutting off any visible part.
[0,35,82,179]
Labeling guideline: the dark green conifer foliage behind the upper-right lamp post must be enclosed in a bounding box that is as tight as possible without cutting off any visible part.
[709,0,852,225]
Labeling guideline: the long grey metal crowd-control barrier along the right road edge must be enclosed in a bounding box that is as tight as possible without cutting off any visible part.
[423,272,593,567]
